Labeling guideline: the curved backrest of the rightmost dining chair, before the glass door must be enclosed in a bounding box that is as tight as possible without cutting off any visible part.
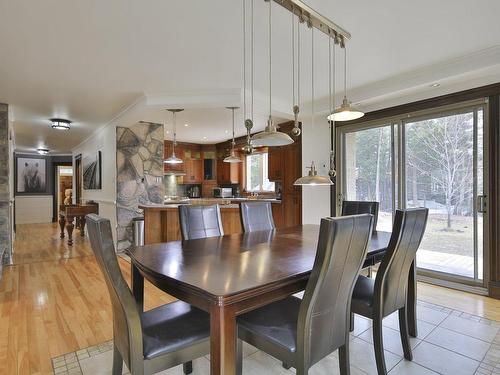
[374,208,429,316]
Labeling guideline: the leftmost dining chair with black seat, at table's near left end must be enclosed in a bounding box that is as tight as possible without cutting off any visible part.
[86,214,210,375]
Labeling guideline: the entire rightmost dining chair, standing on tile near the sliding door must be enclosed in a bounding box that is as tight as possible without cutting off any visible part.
[351,208,429,375]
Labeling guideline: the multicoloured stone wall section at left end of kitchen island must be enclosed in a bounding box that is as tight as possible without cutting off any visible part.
[115,123,164,251]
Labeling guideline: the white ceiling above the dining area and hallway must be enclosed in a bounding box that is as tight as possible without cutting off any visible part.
[0,0,500,152]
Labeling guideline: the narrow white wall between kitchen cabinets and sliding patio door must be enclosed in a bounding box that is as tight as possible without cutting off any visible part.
[302,115,330,224]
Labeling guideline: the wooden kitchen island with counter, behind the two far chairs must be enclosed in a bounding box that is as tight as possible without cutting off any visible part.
[139,199,281,245]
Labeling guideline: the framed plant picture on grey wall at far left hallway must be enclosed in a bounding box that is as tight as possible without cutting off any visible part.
[16,156,47,194]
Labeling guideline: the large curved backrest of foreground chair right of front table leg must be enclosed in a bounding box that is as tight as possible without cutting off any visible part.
[297,214,373,367]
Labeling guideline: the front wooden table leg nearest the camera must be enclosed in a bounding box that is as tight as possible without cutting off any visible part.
[210,305,236,375]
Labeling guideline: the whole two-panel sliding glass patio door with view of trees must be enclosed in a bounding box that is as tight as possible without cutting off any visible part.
[337,104,487,286]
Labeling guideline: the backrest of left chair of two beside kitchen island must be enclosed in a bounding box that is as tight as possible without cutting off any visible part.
[179,204,224,240]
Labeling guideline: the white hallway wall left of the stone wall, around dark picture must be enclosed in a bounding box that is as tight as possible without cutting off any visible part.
[72,124,116,243]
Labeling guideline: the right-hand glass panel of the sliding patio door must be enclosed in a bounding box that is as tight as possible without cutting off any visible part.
[403,108,485,282]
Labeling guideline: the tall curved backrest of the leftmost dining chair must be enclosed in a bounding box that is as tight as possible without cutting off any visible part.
[86,214,143,368]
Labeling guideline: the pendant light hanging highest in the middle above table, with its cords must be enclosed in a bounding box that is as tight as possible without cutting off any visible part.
[252,0,293,147]
